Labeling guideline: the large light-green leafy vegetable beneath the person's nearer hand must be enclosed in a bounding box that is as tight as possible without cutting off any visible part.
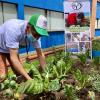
[17,79,43,94]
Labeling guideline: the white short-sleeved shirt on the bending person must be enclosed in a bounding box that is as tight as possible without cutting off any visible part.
[0,19,41,53]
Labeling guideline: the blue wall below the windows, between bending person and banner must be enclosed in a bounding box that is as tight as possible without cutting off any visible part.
[19,31,65,53]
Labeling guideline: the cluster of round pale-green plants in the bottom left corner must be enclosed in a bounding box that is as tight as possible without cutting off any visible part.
[0,74,18,100]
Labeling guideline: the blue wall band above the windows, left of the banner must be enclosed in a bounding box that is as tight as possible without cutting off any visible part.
[0,0,63,12]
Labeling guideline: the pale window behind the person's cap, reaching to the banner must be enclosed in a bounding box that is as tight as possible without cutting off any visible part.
[24,6,64,31]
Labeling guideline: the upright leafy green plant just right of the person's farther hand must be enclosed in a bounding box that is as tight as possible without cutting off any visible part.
[43,53,72,79]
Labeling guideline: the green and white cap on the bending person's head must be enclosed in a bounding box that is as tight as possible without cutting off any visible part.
[29,14,48,36]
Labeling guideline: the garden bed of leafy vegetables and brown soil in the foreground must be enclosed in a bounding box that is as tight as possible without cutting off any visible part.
[0,51,100,100]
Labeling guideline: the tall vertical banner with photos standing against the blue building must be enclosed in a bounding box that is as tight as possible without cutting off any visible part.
[64,0,92,56]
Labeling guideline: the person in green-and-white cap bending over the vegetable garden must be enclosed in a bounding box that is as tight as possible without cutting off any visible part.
[0,14,48,82]
